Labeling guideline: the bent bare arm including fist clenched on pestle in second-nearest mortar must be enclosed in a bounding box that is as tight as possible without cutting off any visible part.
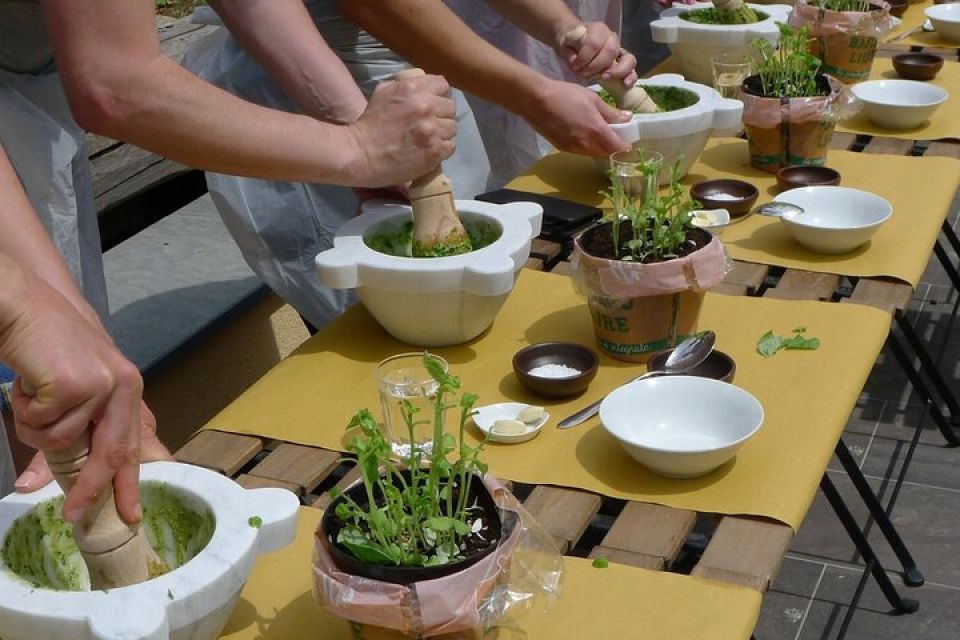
[43,0,456,186]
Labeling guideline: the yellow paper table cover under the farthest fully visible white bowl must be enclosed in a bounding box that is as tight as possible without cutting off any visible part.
[836,58,960,140]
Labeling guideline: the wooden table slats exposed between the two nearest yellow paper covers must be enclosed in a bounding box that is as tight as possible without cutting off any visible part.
[176,430,793,596]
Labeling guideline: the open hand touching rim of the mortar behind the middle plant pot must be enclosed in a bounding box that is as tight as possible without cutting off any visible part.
[526,80,633,156]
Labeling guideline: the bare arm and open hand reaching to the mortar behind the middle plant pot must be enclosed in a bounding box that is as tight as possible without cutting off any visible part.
[338,0,629,155]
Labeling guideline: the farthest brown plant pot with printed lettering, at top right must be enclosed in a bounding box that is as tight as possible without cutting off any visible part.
[789,0,893,83]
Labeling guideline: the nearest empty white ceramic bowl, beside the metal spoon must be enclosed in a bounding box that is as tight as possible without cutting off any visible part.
[600,376,763,478]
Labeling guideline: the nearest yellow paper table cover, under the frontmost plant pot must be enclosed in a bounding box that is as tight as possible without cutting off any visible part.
[221,507,760,640]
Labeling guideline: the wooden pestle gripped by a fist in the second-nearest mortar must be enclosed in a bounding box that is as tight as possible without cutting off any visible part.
[386,68,472,256]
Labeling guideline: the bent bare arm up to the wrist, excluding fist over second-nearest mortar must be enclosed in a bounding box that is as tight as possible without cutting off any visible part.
[44,0,368,185]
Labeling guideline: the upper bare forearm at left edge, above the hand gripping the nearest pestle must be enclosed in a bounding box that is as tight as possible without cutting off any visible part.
[0,148,101,327]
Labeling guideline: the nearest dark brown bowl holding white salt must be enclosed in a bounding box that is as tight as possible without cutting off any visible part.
[513,342,600,398]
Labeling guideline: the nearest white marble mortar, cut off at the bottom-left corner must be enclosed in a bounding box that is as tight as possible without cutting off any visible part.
[0,462,306,640]
